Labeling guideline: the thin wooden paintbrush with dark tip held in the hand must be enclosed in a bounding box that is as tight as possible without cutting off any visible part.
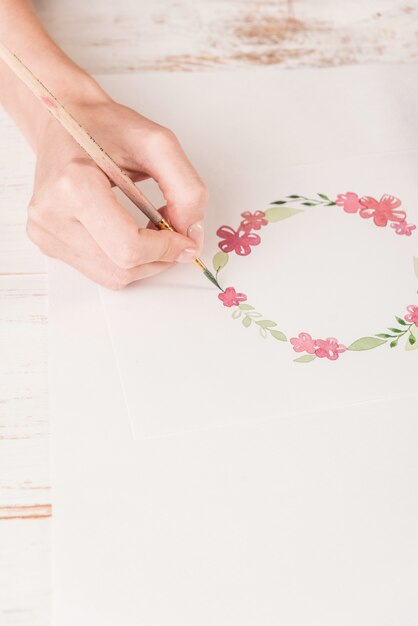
[0,41,223,291]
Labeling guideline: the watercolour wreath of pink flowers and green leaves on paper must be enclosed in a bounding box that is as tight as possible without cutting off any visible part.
[213,191,418,363]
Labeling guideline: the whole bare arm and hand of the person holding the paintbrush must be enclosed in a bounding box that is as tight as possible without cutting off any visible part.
[0,0,207,289]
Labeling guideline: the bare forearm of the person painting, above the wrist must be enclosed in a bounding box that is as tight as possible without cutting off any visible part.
[0,0,106,150]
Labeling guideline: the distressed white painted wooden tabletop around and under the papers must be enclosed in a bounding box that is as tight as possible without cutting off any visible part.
[0,0,418,626]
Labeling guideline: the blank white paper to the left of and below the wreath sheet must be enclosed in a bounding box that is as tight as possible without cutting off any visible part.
[49,258,418,626]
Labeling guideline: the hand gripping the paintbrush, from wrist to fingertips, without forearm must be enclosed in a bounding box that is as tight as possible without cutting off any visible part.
[27,97,207,289]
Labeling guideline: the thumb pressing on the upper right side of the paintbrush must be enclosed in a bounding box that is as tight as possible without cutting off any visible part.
[133,124,208,252]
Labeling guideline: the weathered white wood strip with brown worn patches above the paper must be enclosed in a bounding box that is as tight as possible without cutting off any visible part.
[38,0,418,74]
